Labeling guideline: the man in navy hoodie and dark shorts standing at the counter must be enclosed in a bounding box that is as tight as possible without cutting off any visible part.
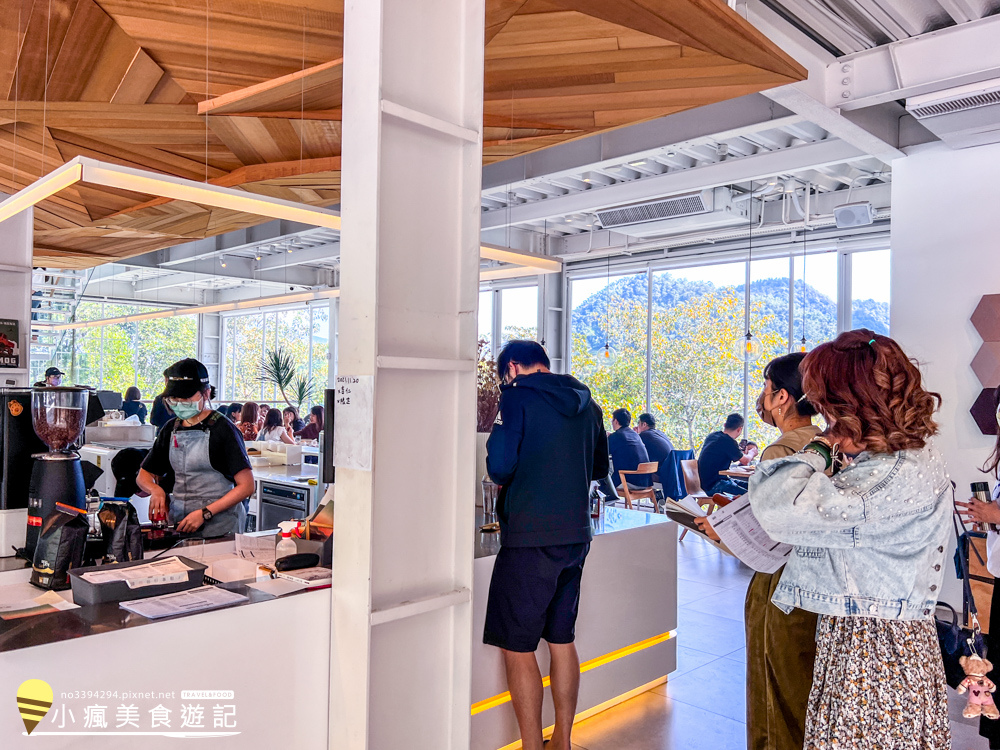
[483,341,608,750]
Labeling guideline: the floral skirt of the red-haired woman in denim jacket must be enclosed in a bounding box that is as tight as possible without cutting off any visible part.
[804,615,951,750]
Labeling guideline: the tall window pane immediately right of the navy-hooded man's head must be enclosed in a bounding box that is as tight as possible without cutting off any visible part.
[570,273,648,428]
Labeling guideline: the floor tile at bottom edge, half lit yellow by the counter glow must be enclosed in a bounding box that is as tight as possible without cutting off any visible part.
[573,692,746,750]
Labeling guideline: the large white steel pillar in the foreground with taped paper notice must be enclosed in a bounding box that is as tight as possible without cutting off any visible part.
[330,0,485,750]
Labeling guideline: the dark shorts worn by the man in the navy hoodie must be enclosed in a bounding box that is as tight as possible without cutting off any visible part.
[483,543,590,652]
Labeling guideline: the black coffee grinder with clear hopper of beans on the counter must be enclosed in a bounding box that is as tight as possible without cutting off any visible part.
[25,387,90,556]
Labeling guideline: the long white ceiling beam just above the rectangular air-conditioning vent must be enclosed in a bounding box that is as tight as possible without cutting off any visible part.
[482,139,866,229]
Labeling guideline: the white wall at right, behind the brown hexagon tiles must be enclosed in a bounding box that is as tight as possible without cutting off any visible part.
[891,144,1000,604]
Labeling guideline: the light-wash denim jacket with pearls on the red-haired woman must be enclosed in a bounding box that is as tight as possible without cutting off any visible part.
[749,442,953,620]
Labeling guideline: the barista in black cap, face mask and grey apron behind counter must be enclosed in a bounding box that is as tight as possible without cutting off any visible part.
[137,359,254,538]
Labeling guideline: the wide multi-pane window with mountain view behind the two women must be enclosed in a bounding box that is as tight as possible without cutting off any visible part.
[570,251,889,450]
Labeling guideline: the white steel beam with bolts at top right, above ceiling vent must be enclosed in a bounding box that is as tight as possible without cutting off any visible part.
[824,16,1000,110]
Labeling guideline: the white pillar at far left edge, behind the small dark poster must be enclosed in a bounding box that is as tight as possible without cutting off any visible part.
[0,208,34,386]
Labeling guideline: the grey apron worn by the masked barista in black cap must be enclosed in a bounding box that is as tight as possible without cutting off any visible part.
[170,417,246,538]
